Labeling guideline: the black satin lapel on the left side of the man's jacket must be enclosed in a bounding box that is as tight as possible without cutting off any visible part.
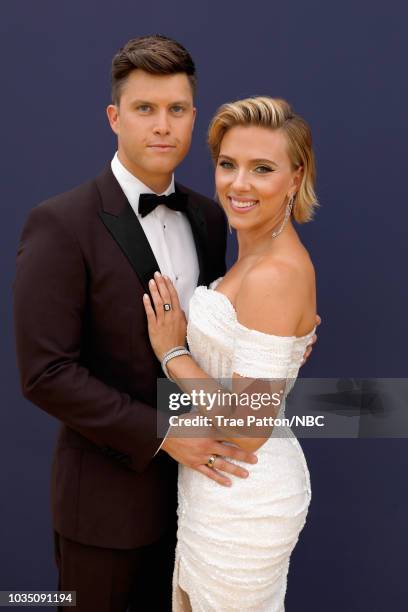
[99,203,160,293]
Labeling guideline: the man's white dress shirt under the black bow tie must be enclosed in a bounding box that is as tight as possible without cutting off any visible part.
[111,153,200,317]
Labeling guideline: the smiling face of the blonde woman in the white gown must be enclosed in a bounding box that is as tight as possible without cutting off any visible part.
[215,126,301,231]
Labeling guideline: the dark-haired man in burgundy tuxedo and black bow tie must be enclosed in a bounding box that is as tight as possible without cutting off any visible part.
[15,36,318,612]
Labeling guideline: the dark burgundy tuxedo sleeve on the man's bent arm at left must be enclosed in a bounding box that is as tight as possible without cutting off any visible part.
[14,205,168,472]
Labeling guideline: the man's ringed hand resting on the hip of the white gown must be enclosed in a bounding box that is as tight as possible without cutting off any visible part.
[161,435,258,487]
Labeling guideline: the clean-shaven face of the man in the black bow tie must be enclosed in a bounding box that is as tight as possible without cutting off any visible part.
[107,69,196,192]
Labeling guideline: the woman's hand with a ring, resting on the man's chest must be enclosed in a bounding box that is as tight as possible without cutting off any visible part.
[143,272,187,361]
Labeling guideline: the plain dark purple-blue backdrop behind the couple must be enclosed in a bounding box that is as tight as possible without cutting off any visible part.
[0,0,408,612]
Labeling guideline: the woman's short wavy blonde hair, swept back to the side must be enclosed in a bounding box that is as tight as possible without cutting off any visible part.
[208,96,318,223]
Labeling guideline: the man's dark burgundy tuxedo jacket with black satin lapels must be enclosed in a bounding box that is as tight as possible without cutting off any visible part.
[14,166,226,549]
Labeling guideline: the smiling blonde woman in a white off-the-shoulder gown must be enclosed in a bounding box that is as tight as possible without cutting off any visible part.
[144,97,316,612]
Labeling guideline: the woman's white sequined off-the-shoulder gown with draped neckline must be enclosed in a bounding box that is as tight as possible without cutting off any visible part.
[173,279,314,612]
